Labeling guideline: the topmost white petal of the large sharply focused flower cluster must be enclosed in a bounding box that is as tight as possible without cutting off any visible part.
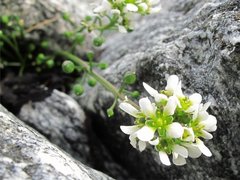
[165,75,184,98]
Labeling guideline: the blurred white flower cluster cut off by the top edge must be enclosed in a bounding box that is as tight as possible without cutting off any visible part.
[93,0,161,33]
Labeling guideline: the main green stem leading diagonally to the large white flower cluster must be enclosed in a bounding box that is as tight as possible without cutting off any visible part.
[58,51,140,109]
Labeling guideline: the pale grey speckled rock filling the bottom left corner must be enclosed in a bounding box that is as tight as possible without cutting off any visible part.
[0,105,112,180]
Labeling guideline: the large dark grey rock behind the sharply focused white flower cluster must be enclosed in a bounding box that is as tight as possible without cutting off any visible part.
[76,0,240,179]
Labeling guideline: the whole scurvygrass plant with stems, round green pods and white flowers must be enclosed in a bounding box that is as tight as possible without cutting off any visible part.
[0,0,217,165]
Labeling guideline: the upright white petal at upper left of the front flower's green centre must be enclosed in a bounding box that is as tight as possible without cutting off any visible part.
[139,97,156,117]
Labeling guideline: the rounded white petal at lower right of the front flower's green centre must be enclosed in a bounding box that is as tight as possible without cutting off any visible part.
[167,122,184,138]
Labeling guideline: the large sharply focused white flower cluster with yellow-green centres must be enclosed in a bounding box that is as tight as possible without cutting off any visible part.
[119,75,217,166]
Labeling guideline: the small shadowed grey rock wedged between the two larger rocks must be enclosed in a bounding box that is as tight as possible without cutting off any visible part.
[18,90,129,178]
